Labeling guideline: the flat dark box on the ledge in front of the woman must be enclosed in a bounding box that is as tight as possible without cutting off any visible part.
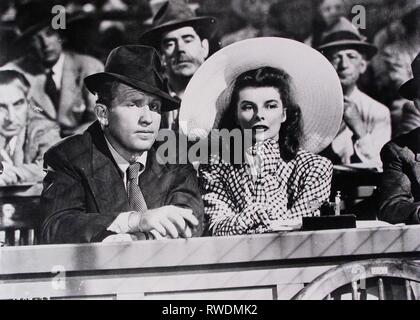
[302,214,356,231]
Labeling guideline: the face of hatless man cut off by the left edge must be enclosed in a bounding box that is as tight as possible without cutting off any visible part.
[0,80,28,138]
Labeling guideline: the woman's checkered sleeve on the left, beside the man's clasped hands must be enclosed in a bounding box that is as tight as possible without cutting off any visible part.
[199,163,268,236]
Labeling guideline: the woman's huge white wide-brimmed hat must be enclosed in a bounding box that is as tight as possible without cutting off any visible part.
[179,37,343,153]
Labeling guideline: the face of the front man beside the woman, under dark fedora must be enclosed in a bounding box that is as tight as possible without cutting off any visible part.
[104,83,162,160]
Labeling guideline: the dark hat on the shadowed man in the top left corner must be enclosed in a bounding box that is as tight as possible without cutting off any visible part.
[15,0,90,44]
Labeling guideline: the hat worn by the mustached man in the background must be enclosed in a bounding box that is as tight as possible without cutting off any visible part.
[139,0,217,50]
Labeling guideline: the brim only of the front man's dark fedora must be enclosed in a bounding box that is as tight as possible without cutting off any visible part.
[84,72,179,112]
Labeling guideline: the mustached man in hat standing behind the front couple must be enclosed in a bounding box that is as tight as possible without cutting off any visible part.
[139,0,216,129]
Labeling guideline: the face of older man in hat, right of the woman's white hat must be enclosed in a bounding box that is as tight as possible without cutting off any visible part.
[327,49,367,88]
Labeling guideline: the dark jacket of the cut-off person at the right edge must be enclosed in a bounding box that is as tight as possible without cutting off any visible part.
[379,128,420,224]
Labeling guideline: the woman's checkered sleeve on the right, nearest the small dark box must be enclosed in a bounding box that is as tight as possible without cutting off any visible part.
[287,156,333,219]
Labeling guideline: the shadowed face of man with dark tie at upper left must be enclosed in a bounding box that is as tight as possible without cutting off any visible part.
[32,28,63,67]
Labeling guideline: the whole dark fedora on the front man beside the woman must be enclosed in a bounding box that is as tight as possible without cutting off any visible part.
[84,45,179,111]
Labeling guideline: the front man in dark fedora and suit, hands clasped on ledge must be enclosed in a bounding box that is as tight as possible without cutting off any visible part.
[41,46,204,243]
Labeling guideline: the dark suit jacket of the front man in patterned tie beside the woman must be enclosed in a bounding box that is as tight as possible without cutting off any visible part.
[41,121,204,243]
